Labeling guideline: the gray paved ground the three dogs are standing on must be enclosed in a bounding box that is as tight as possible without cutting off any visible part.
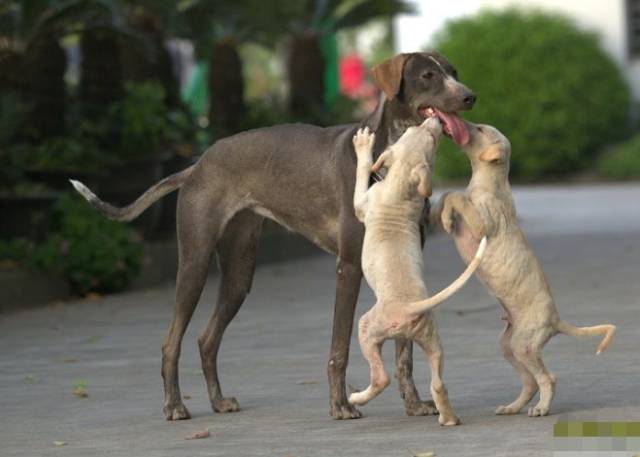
[0,185,640,457]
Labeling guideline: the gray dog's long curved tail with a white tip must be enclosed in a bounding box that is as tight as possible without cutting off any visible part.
[69,165,195,222]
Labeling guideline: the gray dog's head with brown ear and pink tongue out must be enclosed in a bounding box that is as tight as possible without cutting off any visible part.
[372,52,476,146]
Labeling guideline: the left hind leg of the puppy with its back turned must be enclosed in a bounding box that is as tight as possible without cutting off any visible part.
[349,313,391,405]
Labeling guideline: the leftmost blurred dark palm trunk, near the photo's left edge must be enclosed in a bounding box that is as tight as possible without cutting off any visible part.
[24,37,67,139]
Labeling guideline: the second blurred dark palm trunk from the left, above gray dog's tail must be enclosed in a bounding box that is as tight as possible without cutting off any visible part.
[79,28,124,119]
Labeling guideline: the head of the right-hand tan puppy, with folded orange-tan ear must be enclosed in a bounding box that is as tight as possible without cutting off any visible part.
[462,122,511,173]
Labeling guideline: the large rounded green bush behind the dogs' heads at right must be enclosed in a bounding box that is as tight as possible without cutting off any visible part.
[435,9,630,179]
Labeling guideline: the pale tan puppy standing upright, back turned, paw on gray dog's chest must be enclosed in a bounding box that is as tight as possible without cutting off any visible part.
[349,117,484,425]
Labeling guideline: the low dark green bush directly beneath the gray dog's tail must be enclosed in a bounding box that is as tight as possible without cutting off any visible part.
[30,194,142,294]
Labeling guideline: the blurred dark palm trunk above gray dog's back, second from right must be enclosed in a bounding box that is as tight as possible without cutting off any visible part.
[208,39,245,138]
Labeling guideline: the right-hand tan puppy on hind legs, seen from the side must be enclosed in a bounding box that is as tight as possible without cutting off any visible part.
[431,124,616,416]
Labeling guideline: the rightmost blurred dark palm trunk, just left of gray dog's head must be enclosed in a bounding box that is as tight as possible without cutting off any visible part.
[287,33,325,122]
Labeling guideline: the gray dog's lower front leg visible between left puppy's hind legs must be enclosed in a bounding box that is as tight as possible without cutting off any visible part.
[396,338,438,416]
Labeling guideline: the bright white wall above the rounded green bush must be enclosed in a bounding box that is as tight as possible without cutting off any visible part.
[394,0,640,100]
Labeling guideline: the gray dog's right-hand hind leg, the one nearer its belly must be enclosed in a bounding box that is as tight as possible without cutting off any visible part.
[198,211,263,413]
